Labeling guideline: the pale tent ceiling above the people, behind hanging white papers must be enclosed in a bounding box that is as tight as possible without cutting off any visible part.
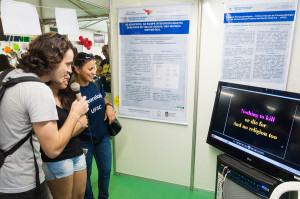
[0,0,109,32]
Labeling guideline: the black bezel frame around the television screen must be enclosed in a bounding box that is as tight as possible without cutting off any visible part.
[206,81,300,181]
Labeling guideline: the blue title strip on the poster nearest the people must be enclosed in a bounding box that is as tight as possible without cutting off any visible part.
[119,20,190,35]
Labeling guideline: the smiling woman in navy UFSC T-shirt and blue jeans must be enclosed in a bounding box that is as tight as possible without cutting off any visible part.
[73,53,116,199]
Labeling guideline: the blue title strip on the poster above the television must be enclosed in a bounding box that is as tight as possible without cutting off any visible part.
[224,10,296,23]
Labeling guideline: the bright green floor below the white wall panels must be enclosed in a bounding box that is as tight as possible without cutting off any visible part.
[91,158,214,199]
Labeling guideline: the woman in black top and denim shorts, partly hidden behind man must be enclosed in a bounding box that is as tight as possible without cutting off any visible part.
[41,76,87,199]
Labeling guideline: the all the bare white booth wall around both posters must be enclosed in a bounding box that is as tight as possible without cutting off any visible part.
[111,0,300,191]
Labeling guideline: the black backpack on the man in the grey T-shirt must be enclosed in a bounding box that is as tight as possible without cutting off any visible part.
[0,69,43,196]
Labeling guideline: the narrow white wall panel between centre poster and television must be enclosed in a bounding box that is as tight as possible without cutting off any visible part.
[195,0,224,190]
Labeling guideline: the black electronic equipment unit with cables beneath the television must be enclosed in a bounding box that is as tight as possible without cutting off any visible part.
[215,154,288,199]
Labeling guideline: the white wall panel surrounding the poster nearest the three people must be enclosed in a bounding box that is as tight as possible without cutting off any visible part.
[111,0,198,186]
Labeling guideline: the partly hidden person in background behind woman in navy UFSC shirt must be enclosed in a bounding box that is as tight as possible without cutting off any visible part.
[100,45,112,102]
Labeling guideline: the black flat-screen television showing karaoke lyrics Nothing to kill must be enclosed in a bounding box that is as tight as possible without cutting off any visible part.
[206,82,300,181]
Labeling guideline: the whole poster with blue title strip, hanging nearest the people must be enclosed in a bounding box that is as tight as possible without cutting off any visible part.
[118,4,191,124]
